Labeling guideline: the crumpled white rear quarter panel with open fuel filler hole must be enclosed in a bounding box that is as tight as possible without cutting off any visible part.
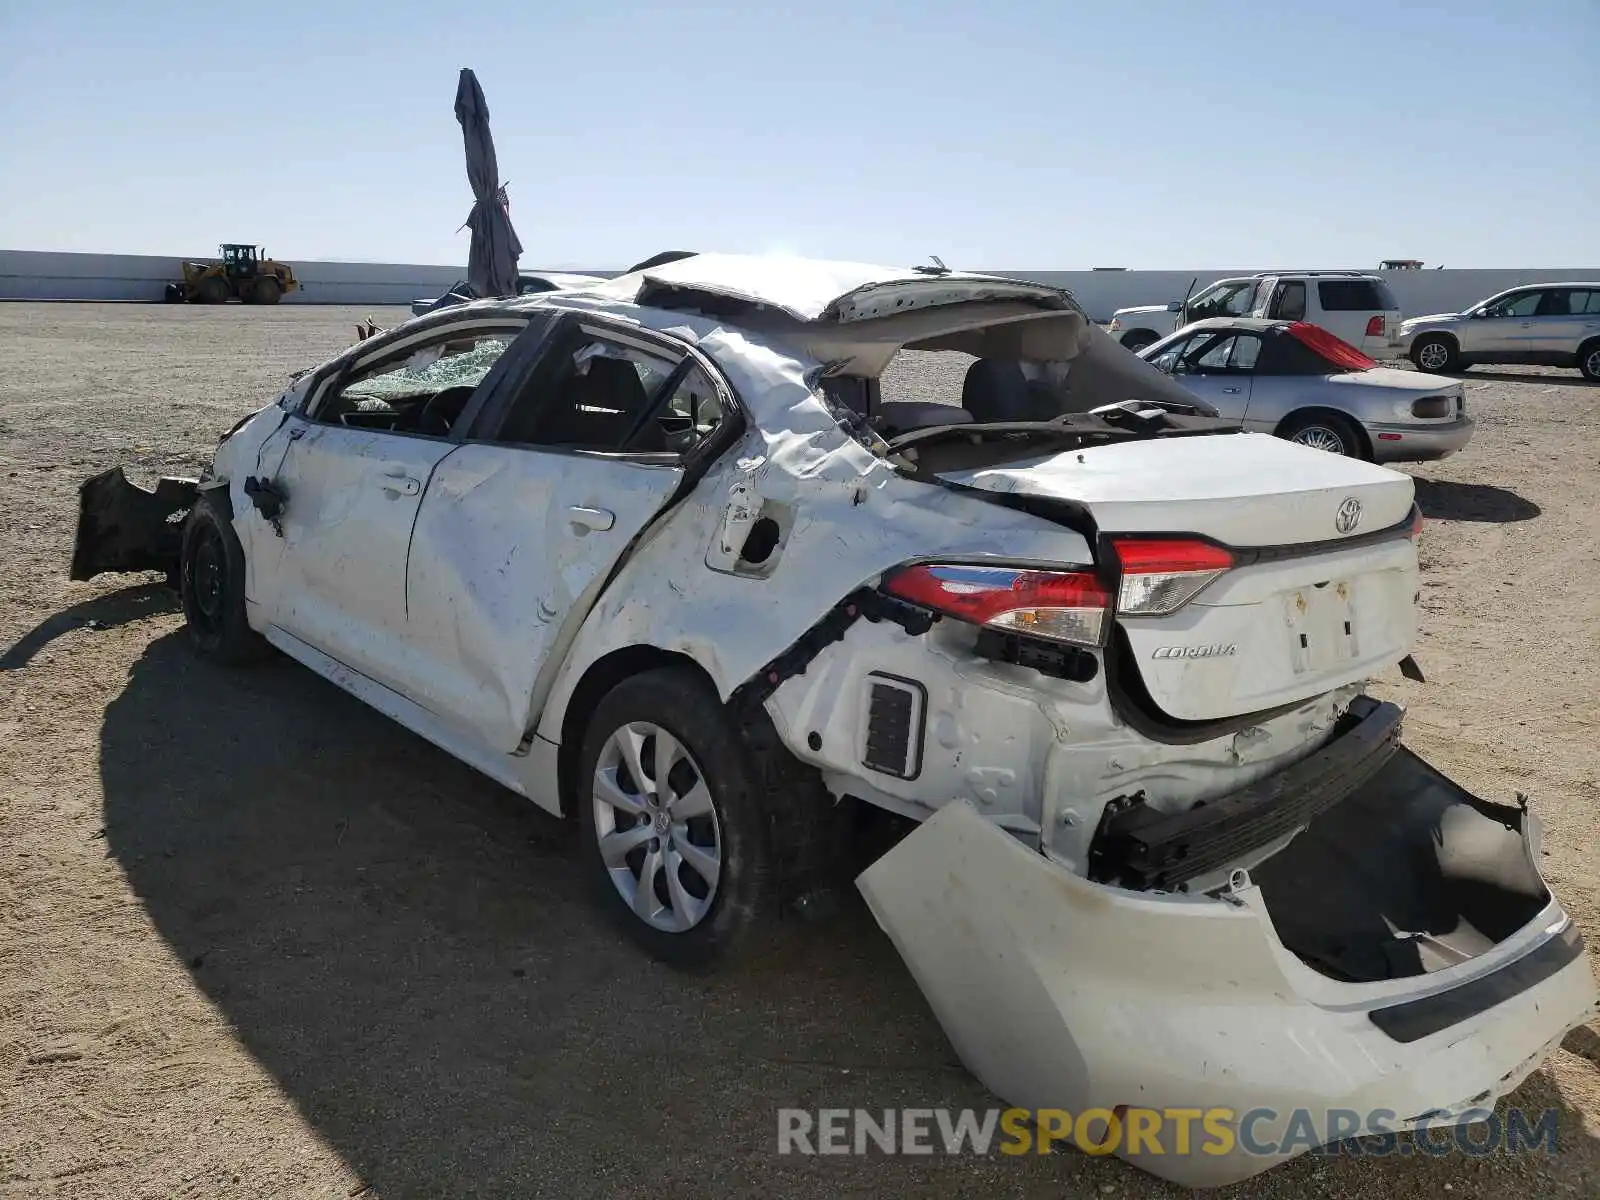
[539,320,1091,741]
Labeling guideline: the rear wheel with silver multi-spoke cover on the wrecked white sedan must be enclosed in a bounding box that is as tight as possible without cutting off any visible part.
[574,667,821,970]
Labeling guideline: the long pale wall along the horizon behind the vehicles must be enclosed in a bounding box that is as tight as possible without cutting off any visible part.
[0,250,1600,322]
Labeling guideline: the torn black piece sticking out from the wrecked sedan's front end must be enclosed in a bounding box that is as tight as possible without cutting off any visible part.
[69,467,200,579]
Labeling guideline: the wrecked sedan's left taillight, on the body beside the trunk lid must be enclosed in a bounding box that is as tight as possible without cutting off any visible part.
[883,563,1110,646]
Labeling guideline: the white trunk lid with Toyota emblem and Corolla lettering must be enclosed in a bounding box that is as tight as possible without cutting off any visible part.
[946,434,1418,720]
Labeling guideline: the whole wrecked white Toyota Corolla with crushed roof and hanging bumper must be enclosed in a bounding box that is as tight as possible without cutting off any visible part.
[72,254,1597,1184]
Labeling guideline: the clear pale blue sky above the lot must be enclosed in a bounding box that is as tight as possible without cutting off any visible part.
[0,0,1600,269]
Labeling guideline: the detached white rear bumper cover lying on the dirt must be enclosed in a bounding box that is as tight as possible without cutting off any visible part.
[858,771,1600,1187]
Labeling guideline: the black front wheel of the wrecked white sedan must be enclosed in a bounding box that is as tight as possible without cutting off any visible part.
[178,493,267,666]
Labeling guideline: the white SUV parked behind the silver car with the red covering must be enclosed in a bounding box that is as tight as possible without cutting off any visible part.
[1109,270,1400,358]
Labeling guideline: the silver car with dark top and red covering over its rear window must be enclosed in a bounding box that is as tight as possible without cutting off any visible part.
[1139,317,1472,462]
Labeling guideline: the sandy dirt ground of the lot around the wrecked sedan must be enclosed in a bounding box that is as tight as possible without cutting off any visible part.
[0,304,1600,1200]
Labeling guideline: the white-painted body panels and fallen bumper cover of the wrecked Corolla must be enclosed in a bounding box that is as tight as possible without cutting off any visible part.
[147,256,1595,1182]
